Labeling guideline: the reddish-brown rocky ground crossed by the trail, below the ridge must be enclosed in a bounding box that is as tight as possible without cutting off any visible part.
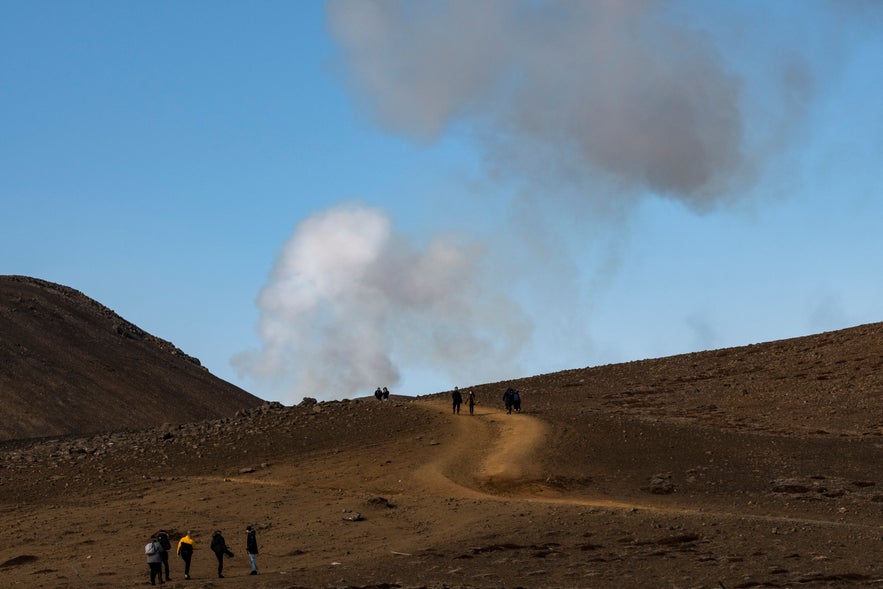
[0,278,883,589]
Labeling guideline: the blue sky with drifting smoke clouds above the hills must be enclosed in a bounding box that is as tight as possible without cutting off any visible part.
[0,0,883,403]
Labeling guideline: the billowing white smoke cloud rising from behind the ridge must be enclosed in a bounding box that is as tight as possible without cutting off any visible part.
[233,205,530,401]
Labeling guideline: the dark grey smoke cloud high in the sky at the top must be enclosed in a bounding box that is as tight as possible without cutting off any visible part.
[328,0,809,210]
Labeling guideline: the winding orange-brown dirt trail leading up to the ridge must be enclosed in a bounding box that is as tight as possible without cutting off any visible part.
[417,401,876,528]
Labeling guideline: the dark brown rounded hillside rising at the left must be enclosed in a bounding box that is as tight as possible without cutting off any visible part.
[0,276,262,440]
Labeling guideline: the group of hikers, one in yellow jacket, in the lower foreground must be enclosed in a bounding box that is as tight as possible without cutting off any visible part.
[144,525,258,585]
